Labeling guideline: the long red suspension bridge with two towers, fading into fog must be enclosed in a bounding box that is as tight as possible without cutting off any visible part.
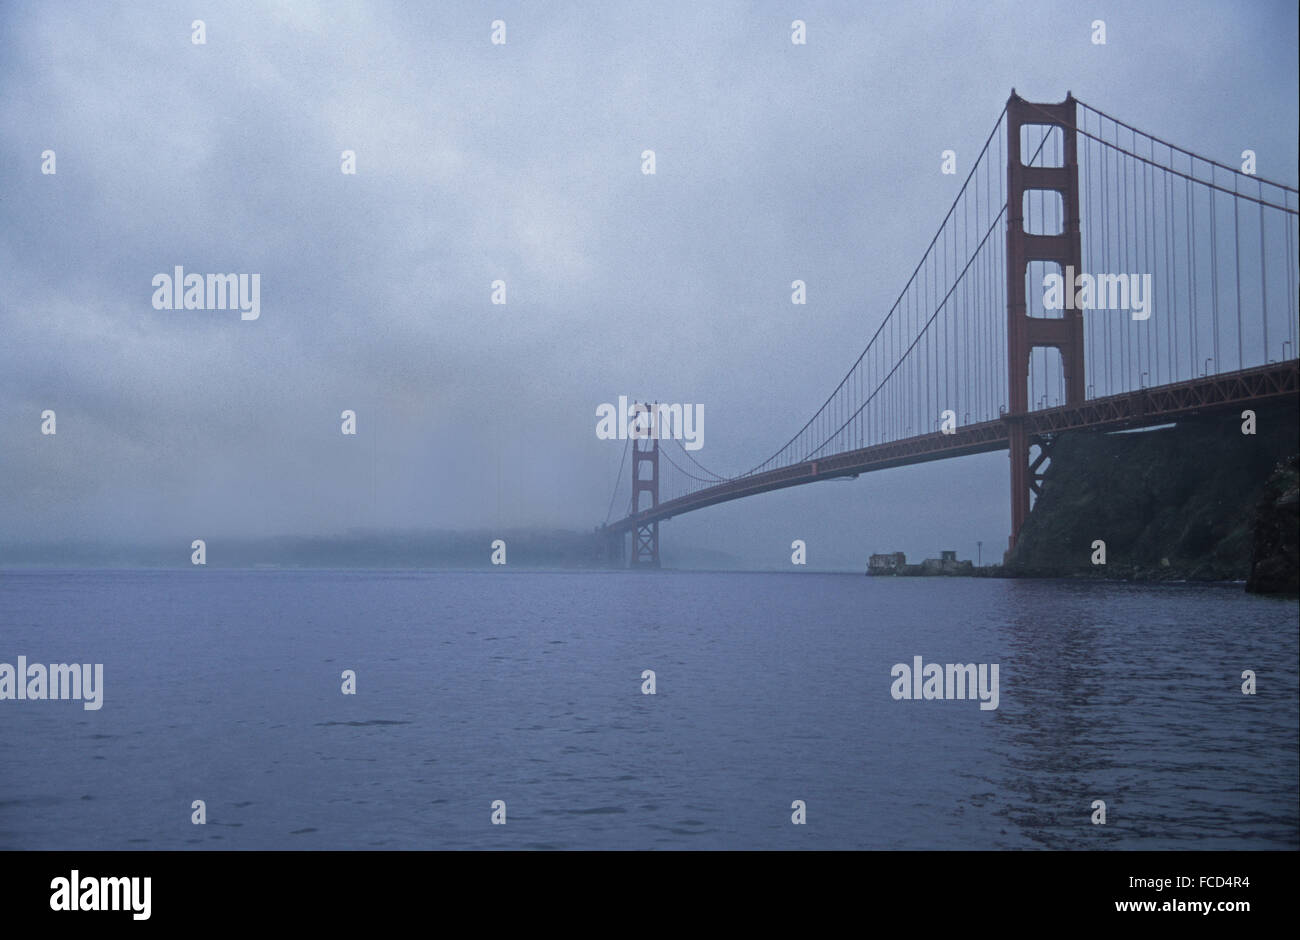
[598,90,1300,567]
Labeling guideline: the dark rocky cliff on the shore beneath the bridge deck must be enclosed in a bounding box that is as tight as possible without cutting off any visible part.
[1004,407,1300,590]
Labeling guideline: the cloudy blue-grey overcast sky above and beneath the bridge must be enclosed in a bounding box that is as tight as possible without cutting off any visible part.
[0,0,1297,568]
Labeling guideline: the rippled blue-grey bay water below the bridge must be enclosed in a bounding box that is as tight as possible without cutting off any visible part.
[0,569,1300,849]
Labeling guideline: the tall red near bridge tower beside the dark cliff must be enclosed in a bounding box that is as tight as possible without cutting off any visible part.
[1004,88,1087,549]
